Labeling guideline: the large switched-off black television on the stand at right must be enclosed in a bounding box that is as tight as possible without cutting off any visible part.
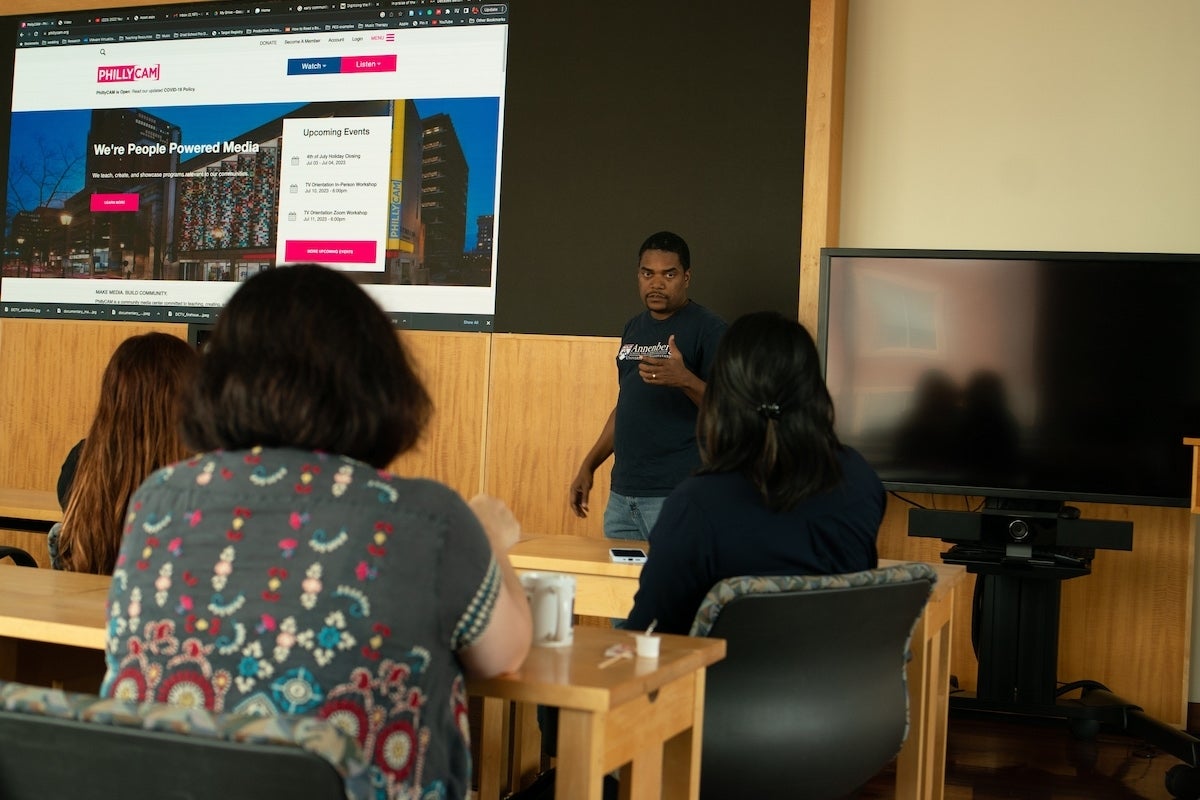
[817,248,1200,506]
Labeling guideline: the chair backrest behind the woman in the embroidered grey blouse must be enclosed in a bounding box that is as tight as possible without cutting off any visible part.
[0,681,374,800]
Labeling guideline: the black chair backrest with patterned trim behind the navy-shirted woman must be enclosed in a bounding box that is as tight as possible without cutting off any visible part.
[691,564,937,800]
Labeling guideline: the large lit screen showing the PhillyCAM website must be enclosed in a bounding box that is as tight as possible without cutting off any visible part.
[0,0,509,330]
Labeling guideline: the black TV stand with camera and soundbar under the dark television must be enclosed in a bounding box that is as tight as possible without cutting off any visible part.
[908,505,1200,799]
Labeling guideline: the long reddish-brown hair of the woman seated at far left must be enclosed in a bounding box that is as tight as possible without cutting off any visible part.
[59,333,199,575]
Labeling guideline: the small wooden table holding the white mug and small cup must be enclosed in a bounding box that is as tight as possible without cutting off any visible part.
[468,626,725,800]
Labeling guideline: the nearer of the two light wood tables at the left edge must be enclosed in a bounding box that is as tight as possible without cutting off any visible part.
[0,564,112,692]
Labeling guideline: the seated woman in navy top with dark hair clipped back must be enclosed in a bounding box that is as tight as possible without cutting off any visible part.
[624,312,886,633]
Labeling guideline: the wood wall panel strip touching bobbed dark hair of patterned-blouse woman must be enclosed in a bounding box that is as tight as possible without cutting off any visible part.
[391,331,492,499]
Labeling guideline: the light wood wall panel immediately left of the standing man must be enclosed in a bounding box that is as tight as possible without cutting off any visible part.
[485,333,619,537]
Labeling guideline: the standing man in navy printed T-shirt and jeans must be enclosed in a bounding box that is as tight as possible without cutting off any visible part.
[570,230,725,540]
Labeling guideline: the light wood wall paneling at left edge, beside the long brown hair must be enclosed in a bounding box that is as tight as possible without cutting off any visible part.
[0,319,187,491]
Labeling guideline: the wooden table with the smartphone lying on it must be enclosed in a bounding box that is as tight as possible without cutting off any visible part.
[509,536,966,800]
